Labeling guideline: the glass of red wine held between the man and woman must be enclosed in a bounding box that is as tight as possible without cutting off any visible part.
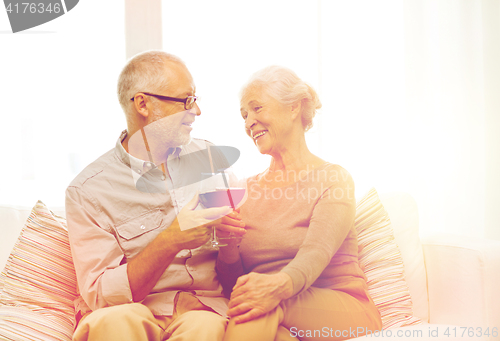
[199,171,246,248]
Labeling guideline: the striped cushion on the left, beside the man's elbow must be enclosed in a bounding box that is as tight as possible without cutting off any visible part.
[0,201,76,341]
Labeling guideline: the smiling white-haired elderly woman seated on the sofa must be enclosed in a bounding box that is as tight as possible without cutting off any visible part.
[217,66,382,341]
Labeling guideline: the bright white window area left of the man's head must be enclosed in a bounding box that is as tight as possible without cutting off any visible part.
[0,1,126,207]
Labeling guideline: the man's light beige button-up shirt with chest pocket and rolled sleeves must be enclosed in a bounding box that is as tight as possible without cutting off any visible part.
[66,131,227,316]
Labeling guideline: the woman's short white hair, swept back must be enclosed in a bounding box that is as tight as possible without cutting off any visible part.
[240,65,321,131]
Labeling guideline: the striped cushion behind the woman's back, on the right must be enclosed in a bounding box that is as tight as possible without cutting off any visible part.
[355,188,422,329]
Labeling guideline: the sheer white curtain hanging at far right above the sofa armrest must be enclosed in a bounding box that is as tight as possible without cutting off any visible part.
[401,0,500,239]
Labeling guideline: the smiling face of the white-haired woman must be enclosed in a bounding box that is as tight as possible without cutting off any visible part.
[240,87,292,154]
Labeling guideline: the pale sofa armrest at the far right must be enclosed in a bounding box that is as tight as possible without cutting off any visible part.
[422,234,500,340]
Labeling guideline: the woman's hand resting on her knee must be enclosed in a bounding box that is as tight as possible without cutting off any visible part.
[227,272,293,324]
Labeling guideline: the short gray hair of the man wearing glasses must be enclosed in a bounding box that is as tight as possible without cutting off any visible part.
[117,50,185,114]
